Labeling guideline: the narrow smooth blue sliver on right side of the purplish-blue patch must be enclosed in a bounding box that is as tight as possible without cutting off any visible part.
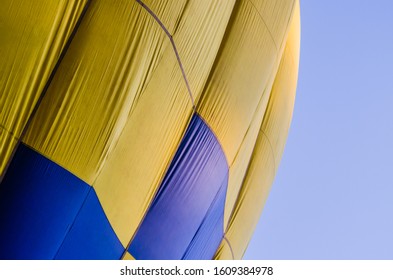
[182,180,228,260]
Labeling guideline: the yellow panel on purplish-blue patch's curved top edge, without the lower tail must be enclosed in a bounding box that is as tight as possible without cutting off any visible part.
[197,0,289,164]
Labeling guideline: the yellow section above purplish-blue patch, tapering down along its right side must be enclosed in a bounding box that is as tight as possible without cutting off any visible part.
[185,0,294,232]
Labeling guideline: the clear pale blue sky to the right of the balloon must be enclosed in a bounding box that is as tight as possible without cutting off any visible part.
[244,0,393,259]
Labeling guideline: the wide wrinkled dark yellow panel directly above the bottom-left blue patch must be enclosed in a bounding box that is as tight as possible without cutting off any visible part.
[24,0,172,184]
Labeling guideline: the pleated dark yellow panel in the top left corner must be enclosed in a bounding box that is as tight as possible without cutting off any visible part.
[0,0,87,175]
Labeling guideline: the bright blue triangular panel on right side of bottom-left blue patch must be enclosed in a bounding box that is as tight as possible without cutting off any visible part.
[55,189,125,260]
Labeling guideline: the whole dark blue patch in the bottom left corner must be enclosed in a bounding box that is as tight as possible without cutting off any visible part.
[0,144,125,259]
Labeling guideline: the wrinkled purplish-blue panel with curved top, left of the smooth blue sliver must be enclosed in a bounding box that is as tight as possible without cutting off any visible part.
[129,114,228,259]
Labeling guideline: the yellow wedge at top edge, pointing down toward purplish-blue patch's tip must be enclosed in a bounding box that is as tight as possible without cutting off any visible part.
[173,0,235,100]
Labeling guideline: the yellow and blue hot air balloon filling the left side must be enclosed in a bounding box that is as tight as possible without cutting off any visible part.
[0,0,300,259]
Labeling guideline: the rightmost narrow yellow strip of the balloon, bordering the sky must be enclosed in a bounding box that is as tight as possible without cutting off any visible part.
[215,2,300,259]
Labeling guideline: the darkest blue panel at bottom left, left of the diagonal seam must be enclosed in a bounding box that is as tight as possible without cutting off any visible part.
[0,144,90,259]
